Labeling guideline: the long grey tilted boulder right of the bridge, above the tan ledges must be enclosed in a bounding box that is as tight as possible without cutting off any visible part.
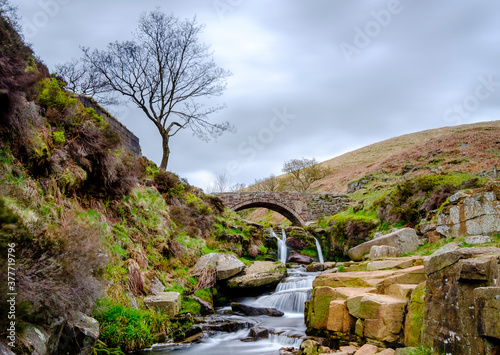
[347,228,419,261]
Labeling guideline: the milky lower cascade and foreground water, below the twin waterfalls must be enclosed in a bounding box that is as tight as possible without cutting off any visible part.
[149,268,317,355]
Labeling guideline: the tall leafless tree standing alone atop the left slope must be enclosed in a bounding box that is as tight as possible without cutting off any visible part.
[71,9,234,170]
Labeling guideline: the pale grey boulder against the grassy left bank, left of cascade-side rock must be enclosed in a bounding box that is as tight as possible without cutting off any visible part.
[191,253,245,280]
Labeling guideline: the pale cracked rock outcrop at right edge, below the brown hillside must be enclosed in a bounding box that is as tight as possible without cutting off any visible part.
[436,187,500,237]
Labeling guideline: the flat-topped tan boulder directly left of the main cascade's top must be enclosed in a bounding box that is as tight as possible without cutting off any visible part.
[227,261,286,288]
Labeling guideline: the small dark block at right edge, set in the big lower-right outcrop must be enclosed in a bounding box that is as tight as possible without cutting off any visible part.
[474,287,500,339]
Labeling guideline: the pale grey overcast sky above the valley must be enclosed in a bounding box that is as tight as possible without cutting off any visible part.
[12,0,500,187]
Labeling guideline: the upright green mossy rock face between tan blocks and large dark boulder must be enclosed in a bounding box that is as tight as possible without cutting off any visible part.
[404,282,426,346]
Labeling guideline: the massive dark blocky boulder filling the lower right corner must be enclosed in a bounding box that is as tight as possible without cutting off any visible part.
[422,244,500,355]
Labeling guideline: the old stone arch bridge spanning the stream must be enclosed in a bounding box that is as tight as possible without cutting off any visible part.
[217,191,348,226]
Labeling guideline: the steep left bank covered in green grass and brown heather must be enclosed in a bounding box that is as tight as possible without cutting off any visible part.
[0,16,274,354]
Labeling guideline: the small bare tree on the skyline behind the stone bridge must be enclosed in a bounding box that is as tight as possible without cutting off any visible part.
[282,158,330,192]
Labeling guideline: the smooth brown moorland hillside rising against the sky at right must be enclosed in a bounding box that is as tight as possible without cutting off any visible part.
[314,121,500,192]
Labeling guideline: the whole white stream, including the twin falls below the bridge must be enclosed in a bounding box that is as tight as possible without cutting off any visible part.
[147,229,323,355]
